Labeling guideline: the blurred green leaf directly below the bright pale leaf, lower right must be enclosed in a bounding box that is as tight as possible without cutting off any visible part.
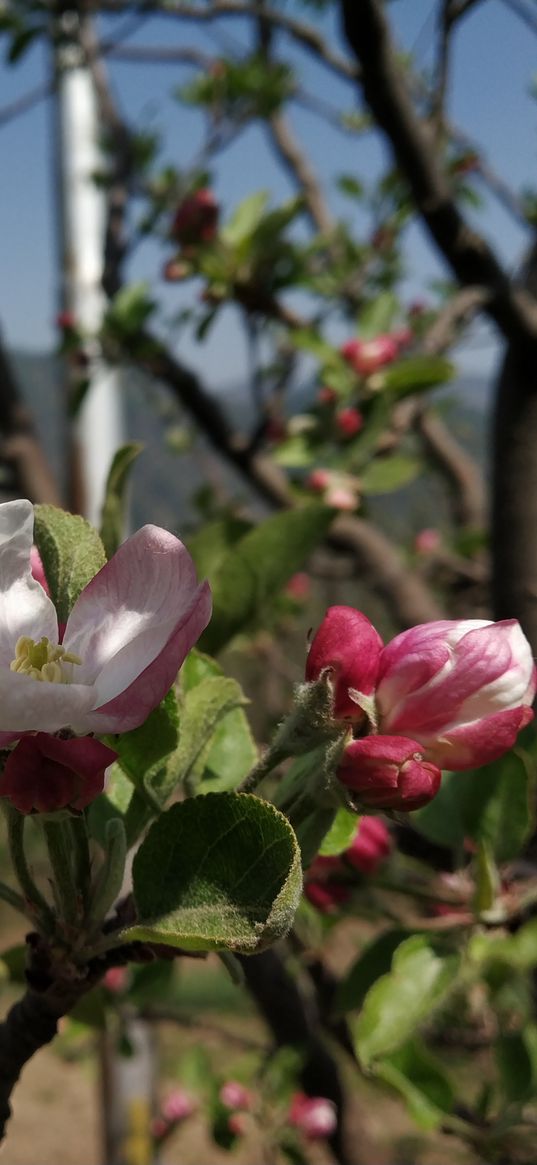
[375,1040,454,1131]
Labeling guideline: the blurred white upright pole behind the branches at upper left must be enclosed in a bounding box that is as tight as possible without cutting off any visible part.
[56,12,126,525]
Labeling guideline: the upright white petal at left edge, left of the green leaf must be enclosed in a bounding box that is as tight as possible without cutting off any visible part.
[0,500,58,669]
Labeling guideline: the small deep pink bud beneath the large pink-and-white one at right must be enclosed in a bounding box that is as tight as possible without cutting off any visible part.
[338,736,441,813]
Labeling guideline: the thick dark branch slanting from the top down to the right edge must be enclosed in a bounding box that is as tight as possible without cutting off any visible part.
[341,0,537,339]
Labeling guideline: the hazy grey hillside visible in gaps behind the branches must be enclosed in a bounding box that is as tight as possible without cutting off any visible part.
[13,352,488,536]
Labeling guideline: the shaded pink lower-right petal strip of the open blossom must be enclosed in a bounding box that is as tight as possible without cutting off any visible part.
[84,581,211,733]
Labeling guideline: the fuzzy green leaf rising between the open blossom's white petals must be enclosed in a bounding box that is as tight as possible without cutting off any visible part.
[34,506,106,623]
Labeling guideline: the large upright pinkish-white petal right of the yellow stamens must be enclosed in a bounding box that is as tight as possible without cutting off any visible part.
[63,525,210,703]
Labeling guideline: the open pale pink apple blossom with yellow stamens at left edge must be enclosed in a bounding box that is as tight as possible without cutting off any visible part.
[0,501,211,747]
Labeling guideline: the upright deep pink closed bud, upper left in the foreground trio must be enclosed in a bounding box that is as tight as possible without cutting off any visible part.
[305,607,382,721]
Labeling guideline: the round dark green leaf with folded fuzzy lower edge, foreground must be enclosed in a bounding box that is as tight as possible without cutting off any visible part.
[122,793,302,954]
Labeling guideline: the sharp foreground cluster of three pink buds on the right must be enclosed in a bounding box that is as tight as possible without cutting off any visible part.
[306,607,536,811]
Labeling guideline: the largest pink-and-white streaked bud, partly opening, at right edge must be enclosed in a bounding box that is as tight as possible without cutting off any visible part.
[376,619,536,770]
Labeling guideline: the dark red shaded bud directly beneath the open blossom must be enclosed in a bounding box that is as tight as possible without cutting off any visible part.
[0,732,116,813]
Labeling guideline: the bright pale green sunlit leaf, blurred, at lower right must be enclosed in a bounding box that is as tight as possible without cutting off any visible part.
[353,934,459,1068]
